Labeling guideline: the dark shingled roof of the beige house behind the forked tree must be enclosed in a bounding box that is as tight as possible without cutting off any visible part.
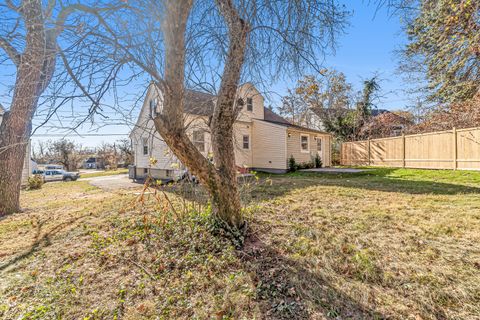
[185,90,327,134]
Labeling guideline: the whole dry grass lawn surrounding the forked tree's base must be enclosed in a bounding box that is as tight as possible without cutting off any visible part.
[0,169,480,319]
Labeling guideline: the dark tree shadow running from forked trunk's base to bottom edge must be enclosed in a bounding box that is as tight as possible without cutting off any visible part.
[239,232,387,319]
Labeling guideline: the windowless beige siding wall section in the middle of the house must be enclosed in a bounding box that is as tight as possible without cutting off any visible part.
[251,121,287,169]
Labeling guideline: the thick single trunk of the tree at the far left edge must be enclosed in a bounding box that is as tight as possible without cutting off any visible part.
[0,0,56,216]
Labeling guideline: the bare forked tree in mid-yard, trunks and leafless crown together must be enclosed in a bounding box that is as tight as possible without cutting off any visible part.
[99,0,347,239]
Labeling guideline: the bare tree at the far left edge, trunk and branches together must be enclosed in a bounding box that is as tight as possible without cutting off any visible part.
[0,0,125,215]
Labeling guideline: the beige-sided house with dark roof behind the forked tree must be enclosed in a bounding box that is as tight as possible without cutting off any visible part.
[130,83,332,179]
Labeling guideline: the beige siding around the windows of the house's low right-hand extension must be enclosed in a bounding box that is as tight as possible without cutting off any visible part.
[287,130,331,167]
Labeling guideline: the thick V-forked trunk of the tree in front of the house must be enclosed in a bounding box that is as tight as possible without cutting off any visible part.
[155,0,247,236]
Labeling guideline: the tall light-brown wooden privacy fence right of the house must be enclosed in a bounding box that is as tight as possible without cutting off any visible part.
[341,127,480,170]
